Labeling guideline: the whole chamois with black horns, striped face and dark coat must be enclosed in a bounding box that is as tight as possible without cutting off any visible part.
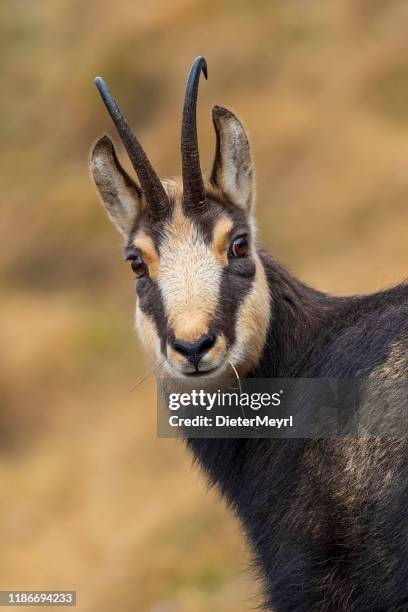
[90,57,408,612]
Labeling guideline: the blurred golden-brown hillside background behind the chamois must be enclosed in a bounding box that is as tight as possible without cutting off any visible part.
[0,0,408,612]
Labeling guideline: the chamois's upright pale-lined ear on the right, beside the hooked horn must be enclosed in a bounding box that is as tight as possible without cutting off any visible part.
[210,106,255,212]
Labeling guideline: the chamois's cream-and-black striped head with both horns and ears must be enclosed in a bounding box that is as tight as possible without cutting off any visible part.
[90,57,270,378]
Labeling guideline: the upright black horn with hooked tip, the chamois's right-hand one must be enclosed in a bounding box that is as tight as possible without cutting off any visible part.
[181,56,208,213]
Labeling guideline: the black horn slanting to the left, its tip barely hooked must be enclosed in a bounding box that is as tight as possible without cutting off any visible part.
[95,77,169,218]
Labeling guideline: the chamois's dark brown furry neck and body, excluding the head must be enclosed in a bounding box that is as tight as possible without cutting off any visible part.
[188,253,408,612]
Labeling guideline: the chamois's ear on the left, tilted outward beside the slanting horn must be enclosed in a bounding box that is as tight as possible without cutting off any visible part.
[90,135,142,238]
